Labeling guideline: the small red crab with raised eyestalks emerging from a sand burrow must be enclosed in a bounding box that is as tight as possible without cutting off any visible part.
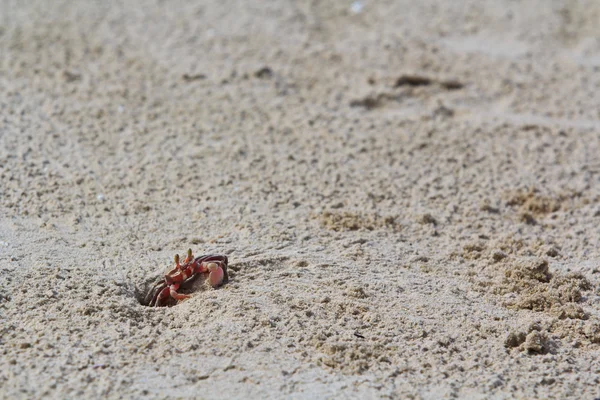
[146,249,229,307]
